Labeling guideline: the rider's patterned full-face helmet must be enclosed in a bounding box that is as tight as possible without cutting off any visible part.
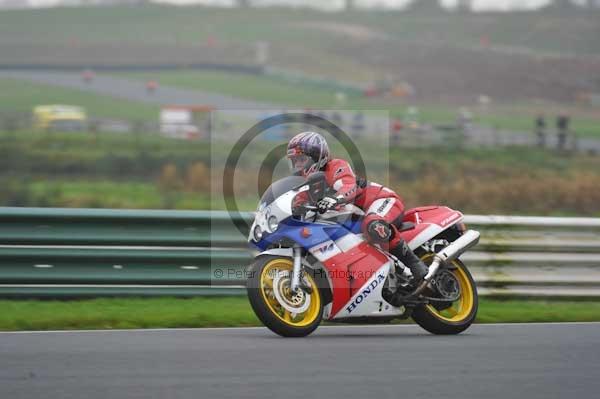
[287,132,329,177]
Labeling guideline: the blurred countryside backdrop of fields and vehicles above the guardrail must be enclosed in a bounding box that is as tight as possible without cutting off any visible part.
[0,0,600,216]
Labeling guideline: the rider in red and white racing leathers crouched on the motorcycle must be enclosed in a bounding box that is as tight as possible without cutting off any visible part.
[287,132,428,286]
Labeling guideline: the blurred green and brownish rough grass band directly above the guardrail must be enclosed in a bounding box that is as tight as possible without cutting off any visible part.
[0,132,600,216]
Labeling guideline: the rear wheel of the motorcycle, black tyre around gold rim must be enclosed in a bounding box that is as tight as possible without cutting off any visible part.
[412,254,479,334]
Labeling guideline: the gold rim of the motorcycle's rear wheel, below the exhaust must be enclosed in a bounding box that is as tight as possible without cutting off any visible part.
[423,254,475,323]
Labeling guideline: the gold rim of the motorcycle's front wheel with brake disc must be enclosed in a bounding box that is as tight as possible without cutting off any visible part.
[259,258,321,327]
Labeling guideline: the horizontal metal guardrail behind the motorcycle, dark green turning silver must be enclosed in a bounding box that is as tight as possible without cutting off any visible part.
[0,207,600,298]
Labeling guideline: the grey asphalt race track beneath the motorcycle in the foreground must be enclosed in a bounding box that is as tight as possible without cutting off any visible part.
[0,323,600,399]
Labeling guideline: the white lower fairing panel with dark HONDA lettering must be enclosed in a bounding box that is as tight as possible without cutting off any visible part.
[333,261,404,319]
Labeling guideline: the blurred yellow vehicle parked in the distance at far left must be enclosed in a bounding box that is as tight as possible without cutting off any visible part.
[33,105,87,132]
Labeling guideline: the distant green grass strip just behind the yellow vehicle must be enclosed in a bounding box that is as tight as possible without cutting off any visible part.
[0,78,159,121]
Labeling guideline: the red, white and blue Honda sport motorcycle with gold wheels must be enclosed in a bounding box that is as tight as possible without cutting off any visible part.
[247,173,480,337]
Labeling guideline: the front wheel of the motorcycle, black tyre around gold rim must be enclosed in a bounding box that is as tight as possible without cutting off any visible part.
[246,256,323,337]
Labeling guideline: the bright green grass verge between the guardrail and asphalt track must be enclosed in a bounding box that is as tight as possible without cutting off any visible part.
[0,297,600,330]
